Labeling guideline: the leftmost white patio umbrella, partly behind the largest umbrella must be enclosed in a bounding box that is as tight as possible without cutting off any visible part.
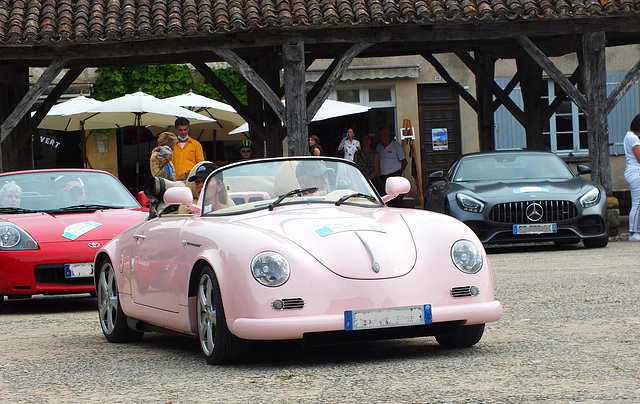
[31,94,118,168]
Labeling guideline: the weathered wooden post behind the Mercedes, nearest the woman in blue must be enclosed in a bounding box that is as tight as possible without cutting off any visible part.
[582,31,613,196]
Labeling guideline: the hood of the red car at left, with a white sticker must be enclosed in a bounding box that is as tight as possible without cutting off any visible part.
[0,209,148,243]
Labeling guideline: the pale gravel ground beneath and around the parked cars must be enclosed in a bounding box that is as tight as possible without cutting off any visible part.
[0,241,640,403]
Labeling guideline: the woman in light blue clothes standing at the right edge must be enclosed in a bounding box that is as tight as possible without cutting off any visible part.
[623,115,640,241]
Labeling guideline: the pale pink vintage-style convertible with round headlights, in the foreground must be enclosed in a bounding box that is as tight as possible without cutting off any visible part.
[95,157,502,364]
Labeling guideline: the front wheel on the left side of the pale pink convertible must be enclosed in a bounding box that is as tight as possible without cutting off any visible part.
[196,266,246,365]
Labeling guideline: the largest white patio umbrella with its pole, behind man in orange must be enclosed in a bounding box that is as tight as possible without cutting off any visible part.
[65,90,213,190]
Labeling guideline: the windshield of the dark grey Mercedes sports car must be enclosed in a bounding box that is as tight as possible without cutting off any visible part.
[453,153,573,182]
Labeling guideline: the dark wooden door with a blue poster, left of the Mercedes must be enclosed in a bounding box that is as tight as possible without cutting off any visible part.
[418,85,462,185]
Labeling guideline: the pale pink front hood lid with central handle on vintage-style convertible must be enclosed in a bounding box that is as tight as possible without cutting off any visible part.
[238,207,416,279]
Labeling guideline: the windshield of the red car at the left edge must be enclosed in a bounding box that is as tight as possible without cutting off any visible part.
[0,170,140,214]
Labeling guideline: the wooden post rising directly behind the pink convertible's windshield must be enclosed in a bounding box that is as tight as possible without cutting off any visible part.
[282,40,309,156]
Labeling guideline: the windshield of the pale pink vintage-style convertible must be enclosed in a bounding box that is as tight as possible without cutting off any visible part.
[202,157,382,214]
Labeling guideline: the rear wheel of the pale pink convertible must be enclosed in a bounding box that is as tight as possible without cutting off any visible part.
[97,261,144,342]
